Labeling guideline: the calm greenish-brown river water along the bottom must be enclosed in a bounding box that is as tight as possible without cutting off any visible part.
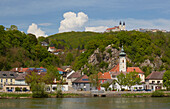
[0,97,170,109]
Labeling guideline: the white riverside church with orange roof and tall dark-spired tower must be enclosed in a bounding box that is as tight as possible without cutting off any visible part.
[109,46,145,89]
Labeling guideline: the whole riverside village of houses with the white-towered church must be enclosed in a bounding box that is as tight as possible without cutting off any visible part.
[0,46,166,92]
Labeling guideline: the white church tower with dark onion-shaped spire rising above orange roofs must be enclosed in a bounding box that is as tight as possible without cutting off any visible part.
[119,45,126,72]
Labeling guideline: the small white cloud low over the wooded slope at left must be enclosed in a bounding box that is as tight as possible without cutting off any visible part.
[27,23,47,38]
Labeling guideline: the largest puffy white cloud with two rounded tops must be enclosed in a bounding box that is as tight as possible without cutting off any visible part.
[59,12,88,32]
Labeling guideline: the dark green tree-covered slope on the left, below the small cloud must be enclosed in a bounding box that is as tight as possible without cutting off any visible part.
[0,25,59,71]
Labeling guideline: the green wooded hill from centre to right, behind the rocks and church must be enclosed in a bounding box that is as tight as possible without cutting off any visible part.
[48,31,170,76]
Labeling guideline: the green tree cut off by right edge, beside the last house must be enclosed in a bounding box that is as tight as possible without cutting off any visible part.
[163,70,170,90]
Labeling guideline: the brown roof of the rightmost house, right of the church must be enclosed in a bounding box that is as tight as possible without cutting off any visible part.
[146,71,165,80]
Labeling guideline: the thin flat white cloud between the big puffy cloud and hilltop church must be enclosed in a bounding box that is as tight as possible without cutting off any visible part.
[85,26,108,32]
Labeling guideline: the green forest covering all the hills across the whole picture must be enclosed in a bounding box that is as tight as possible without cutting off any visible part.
[0,25,170,76]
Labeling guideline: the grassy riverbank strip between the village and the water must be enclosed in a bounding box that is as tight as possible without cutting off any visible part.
[0,91,170,99]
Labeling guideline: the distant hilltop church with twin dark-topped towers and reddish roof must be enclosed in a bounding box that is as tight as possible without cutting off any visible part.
[106,21,126,32]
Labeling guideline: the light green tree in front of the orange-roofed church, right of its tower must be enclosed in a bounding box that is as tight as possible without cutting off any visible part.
[126,71,141,90]
